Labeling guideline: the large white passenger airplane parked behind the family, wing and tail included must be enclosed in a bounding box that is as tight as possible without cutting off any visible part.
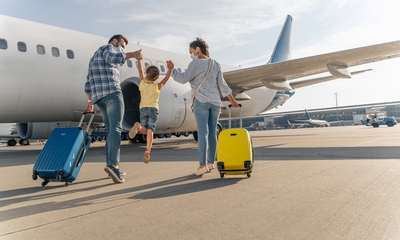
[0,15,400,142]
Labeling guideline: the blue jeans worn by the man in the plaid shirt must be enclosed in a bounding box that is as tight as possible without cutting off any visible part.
[96,92,125,165]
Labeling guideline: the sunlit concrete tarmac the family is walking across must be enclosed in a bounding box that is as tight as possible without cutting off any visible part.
[0,126,400,240]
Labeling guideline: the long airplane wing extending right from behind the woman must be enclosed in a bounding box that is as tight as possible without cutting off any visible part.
[224,41,400,93]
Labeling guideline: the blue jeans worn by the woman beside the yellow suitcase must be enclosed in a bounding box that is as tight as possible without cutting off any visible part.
[193,99,221,166]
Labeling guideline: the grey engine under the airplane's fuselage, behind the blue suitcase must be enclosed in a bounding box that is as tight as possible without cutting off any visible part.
[17,122,78,139]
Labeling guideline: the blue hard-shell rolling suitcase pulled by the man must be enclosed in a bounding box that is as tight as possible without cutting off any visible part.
[32,113,94,187]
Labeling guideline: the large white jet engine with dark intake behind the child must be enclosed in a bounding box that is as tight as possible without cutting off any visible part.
[121,75,196,134]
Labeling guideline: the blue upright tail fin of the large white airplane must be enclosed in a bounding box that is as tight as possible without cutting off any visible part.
[268,15,293,63]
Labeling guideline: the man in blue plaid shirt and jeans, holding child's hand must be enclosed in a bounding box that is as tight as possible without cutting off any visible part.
[85,34,142,183]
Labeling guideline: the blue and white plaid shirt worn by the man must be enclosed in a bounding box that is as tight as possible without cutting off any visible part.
[85,44,126,104]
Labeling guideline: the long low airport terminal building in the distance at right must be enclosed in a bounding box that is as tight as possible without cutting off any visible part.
[220,101,400,130]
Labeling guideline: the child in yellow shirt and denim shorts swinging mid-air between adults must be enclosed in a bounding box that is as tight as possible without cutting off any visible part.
[129,54,173,163]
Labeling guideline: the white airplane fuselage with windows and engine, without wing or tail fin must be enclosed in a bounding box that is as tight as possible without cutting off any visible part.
[0,15,276,138]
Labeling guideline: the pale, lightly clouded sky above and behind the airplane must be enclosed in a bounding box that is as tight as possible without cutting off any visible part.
[0,0,400,113]
